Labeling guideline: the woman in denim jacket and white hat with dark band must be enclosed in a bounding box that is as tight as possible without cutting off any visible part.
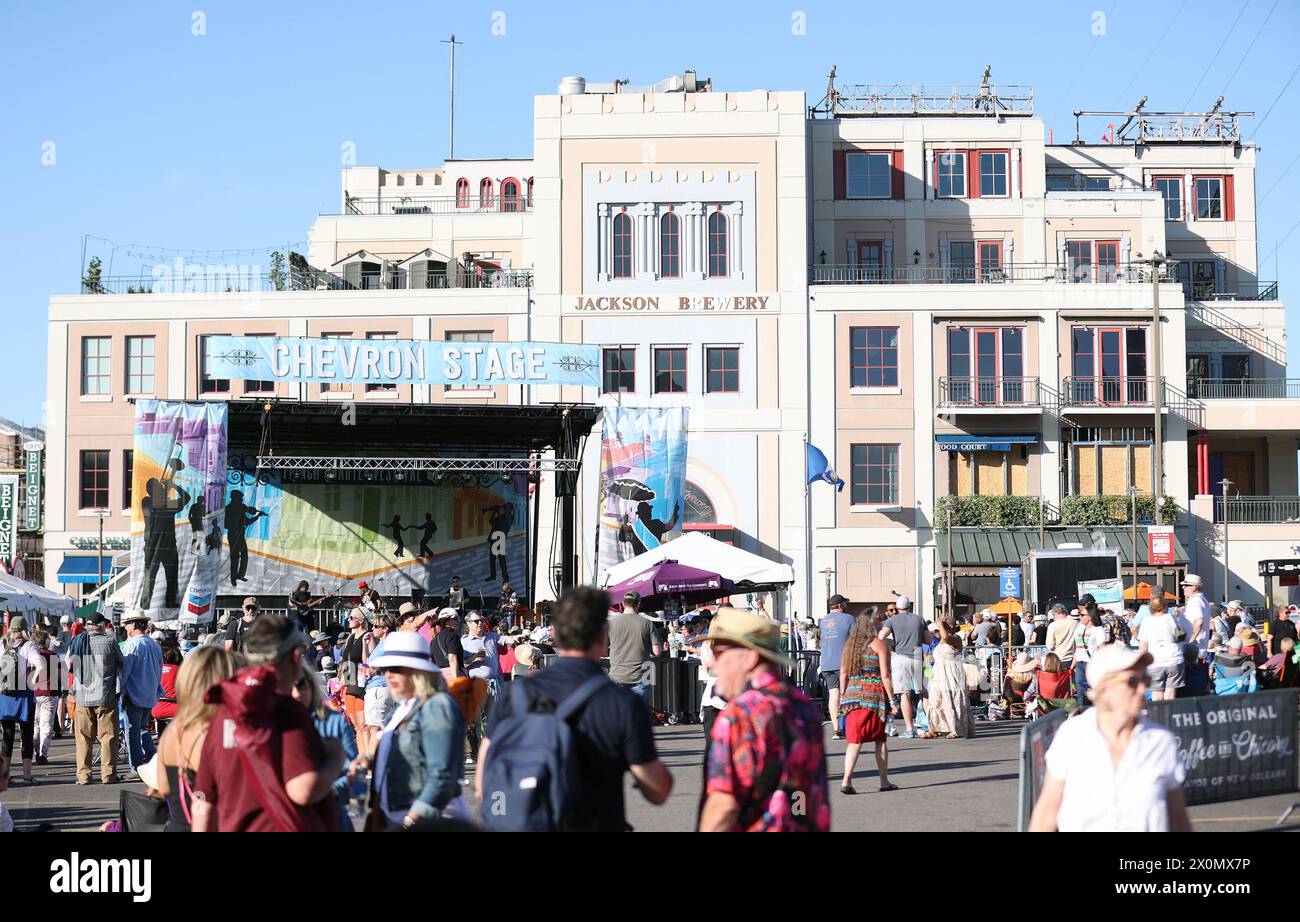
[354,631,468,828]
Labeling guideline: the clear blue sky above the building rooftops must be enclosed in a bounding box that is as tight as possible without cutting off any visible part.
[0,0,1300,423]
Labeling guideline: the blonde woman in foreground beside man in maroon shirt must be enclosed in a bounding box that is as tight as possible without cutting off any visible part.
[157,646,243,832]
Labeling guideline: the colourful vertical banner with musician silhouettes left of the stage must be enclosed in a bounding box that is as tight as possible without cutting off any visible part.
[131,401,228,624]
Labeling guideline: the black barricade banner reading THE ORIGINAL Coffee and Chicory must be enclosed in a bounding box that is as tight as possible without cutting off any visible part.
[1147,688,1297,805]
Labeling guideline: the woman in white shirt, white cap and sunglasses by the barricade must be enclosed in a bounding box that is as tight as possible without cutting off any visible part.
[1030,644,1192,832]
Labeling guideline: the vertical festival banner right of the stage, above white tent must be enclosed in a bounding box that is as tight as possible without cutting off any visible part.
[597,407,686,571]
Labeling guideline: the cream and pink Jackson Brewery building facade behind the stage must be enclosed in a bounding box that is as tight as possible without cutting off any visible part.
[47,73,1300,614]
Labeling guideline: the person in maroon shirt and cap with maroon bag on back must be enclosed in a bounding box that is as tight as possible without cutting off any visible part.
[189,614,343,832]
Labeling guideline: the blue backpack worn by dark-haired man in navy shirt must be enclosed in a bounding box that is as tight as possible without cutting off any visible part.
[482,675,610,832]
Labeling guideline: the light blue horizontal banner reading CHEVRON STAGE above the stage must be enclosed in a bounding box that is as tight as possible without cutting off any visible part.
[204,336,601,388]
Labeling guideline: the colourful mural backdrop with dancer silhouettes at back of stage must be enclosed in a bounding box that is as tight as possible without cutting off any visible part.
[221,458,528,605]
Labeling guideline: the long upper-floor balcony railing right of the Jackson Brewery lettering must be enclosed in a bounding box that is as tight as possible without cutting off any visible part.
[809,263,1151,285]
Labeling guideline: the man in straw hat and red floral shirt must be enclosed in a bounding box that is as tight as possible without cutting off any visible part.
[699,607,831,832]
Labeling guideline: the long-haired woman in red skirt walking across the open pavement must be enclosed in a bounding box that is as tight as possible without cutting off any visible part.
[840,606,898,795]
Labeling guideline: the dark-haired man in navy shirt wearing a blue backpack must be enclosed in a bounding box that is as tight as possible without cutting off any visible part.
[475,586,672,832]
